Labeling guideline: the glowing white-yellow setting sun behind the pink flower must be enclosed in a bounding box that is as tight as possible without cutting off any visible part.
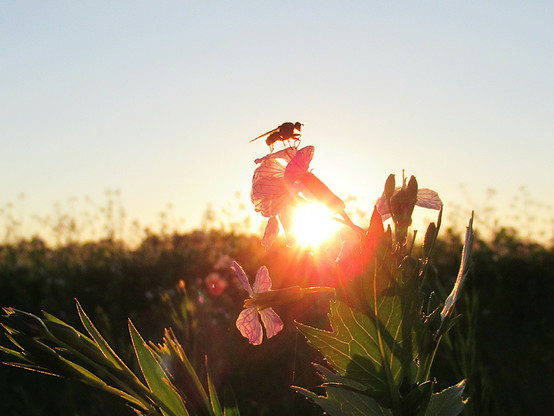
[292,202,340,247]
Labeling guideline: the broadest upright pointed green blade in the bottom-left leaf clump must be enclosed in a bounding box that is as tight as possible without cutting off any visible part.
[129,320,188,416]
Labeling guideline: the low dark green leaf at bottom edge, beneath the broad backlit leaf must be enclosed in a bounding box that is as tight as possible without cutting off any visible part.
[293,385,393,416]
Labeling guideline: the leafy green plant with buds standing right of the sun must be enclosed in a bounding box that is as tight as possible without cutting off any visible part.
[297,193,473,416]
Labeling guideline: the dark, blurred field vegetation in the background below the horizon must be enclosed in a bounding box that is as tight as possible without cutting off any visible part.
[0,229,554,416]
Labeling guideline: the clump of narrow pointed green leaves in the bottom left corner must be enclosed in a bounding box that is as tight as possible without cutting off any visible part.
[1,304,234,416]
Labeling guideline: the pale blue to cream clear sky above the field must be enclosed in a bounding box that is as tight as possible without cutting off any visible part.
[0,1,554,244]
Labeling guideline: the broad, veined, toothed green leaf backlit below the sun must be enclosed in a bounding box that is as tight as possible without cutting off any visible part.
[297,295,416,397]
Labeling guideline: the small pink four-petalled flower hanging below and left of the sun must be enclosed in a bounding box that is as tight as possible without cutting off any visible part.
[231,262,283,345]
